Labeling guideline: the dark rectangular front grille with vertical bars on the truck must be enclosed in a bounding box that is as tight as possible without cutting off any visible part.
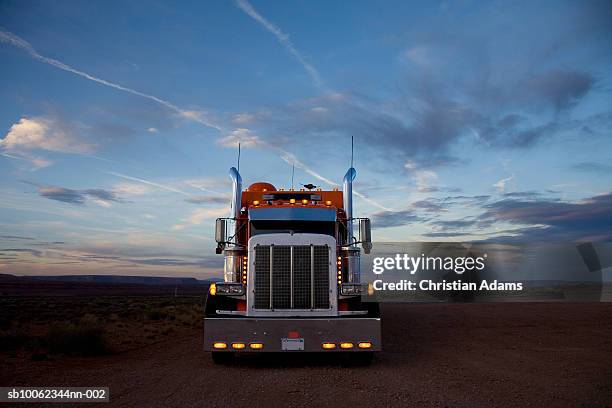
[254,245,330,310]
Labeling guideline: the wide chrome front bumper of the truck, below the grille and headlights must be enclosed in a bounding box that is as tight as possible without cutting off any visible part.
[204,317,381,353]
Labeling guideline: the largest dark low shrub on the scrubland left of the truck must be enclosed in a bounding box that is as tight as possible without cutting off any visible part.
[43,315,110,356]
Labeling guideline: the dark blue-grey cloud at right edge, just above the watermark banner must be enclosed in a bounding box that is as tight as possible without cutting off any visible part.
[481,193,612,241]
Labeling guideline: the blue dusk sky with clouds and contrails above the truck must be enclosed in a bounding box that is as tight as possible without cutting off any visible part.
[0,0,612,278]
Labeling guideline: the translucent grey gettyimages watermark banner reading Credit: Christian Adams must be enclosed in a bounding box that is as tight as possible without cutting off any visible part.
[361,242,612,302]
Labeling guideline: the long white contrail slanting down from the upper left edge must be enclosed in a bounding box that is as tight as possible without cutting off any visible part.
[0,28,221,130]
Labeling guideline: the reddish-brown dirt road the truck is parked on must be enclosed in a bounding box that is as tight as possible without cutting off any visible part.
[0,303,612,407]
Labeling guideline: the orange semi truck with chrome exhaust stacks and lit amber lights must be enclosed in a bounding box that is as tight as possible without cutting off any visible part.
[204,167,381,363]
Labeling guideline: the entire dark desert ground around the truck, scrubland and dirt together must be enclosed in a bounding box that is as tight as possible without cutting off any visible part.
[0,283,612,407]
